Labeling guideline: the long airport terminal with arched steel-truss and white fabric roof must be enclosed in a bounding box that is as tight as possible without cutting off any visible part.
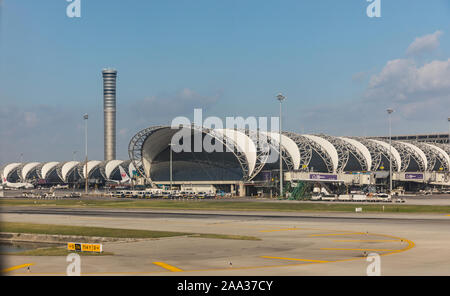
[0,125,450,196]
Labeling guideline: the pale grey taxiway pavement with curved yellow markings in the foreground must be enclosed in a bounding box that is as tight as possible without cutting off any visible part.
[1,202,450,276]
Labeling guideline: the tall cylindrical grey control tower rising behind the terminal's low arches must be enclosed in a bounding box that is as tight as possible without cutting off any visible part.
[102,69,117,160]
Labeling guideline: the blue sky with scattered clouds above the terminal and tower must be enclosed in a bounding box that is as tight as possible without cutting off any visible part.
[0,0,450,163]
